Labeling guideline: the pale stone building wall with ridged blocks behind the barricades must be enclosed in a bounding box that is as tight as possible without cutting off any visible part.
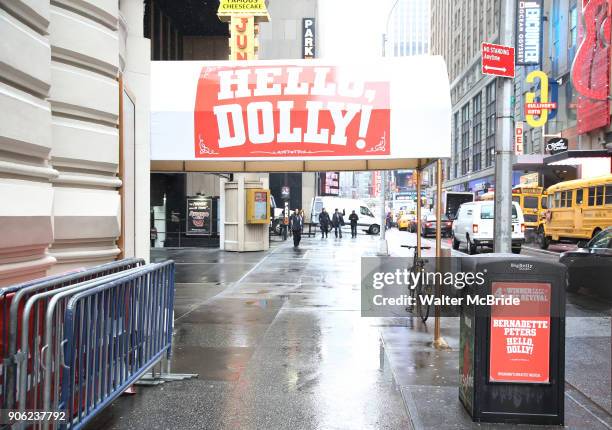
[0,0,150,286]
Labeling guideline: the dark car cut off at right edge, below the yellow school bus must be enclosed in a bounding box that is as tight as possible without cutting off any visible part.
[559,227,612,297]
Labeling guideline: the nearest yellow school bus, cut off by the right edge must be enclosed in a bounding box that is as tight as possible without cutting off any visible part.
[538,174,612,249]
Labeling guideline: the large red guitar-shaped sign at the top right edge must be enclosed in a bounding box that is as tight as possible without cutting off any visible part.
[572,0,610,134]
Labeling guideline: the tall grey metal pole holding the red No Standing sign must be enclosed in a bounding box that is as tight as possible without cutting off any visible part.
[494,1,516,253]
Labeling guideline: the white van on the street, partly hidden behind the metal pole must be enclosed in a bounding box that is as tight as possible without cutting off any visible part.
[453,201,525,254]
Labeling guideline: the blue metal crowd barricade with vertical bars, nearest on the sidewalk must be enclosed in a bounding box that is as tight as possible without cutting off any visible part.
[60,261,174,429]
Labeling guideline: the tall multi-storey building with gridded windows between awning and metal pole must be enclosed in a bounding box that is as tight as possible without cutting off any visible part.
[431,0,500,197]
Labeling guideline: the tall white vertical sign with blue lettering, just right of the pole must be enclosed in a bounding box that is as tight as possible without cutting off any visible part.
[516,0,543,66]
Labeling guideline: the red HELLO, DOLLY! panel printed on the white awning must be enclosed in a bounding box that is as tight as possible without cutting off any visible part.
[194,66,390,159]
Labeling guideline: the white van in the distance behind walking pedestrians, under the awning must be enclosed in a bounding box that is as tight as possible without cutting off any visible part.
[310,196,380,234]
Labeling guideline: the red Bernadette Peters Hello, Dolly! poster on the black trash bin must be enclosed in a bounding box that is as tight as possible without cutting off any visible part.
[489,282,551,384]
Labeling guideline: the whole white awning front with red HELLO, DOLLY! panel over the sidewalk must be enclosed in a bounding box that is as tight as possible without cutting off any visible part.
[151,57,450,160]
